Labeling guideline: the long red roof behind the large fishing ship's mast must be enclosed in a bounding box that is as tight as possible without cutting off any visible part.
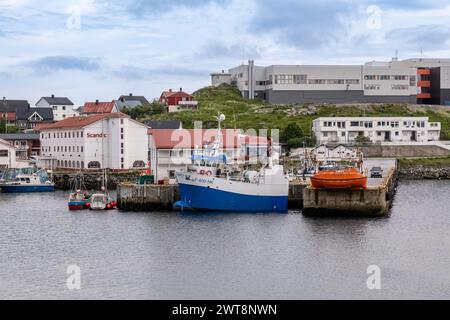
[148,129,267,149]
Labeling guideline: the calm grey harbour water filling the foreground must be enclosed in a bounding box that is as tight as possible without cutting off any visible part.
[0,181,450,299]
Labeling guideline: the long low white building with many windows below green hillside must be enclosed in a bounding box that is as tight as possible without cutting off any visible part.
[312,117,441,144]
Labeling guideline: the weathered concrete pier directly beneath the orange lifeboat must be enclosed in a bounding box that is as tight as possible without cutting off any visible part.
[302,161,397,216]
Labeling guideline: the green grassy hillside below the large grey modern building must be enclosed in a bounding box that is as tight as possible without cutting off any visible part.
[140,85,450,140]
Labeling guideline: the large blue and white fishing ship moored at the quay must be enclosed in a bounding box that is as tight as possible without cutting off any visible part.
[174,115,289,212]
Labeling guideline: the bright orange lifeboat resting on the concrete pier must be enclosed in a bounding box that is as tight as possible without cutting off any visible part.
[311,168,367,189]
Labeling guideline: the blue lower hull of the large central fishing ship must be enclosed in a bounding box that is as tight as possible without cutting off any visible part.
[174,184,288,212]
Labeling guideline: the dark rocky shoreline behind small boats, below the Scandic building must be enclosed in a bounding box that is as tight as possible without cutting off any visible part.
[53,173,138,190]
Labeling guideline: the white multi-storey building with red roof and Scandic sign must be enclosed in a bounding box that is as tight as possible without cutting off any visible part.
[36,113,148,169]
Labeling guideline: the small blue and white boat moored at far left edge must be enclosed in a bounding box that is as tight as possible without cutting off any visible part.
[0,170,55,193]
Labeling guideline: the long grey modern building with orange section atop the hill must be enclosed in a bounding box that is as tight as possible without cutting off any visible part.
[211,59,450,105]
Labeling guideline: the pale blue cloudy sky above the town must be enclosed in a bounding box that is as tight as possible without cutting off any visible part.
[0,0,450,105]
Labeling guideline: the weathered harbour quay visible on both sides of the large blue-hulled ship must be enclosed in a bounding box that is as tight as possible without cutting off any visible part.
[117,158,398,216]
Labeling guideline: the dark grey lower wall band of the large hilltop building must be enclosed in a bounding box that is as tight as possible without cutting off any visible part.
[265,90,417,104]
